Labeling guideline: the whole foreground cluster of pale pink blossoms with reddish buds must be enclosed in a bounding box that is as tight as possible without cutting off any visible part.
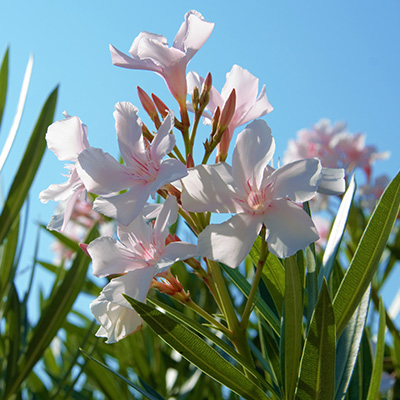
[40,11,346,343]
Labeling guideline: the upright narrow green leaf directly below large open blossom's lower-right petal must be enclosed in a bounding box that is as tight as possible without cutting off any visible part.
[281,255,303,399]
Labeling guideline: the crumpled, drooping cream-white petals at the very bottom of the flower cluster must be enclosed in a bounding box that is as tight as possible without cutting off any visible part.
[90,268,154,343]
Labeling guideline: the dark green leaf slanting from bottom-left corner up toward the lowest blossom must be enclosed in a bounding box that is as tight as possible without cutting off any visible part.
[8,226,98,395]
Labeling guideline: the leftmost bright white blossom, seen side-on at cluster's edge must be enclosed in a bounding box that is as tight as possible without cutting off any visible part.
[39,112,89,232]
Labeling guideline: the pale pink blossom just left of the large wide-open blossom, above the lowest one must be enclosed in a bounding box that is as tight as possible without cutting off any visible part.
[78,102,187,225]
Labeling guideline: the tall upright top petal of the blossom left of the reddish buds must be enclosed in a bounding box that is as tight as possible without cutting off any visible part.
[114,101,146,165]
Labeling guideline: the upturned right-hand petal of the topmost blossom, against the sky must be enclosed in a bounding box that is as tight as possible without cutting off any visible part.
[174,10,214,61]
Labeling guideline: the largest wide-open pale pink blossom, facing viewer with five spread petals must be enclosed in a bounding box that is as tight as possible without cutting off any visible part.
[181,120,346,267]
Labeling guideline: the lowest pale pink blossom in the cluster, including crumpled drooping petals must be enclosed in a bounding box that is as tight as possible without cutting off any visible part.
[87,196,197,343]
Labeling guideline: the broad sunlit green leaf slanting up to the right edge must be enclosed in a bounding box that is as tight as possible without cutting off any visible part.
[333,172,400,335]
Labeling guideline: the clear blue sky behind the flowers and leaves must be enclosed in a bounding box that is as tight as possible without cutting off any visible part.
[0,0,400,316]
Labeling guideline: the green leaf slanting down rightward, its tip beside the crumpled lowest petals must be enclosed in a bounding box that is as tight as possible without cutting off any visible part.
[125,296,269,400]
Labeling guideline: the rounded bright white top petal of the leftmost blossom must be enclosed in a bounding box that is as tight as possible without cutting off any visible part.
[46,117,89,161]
